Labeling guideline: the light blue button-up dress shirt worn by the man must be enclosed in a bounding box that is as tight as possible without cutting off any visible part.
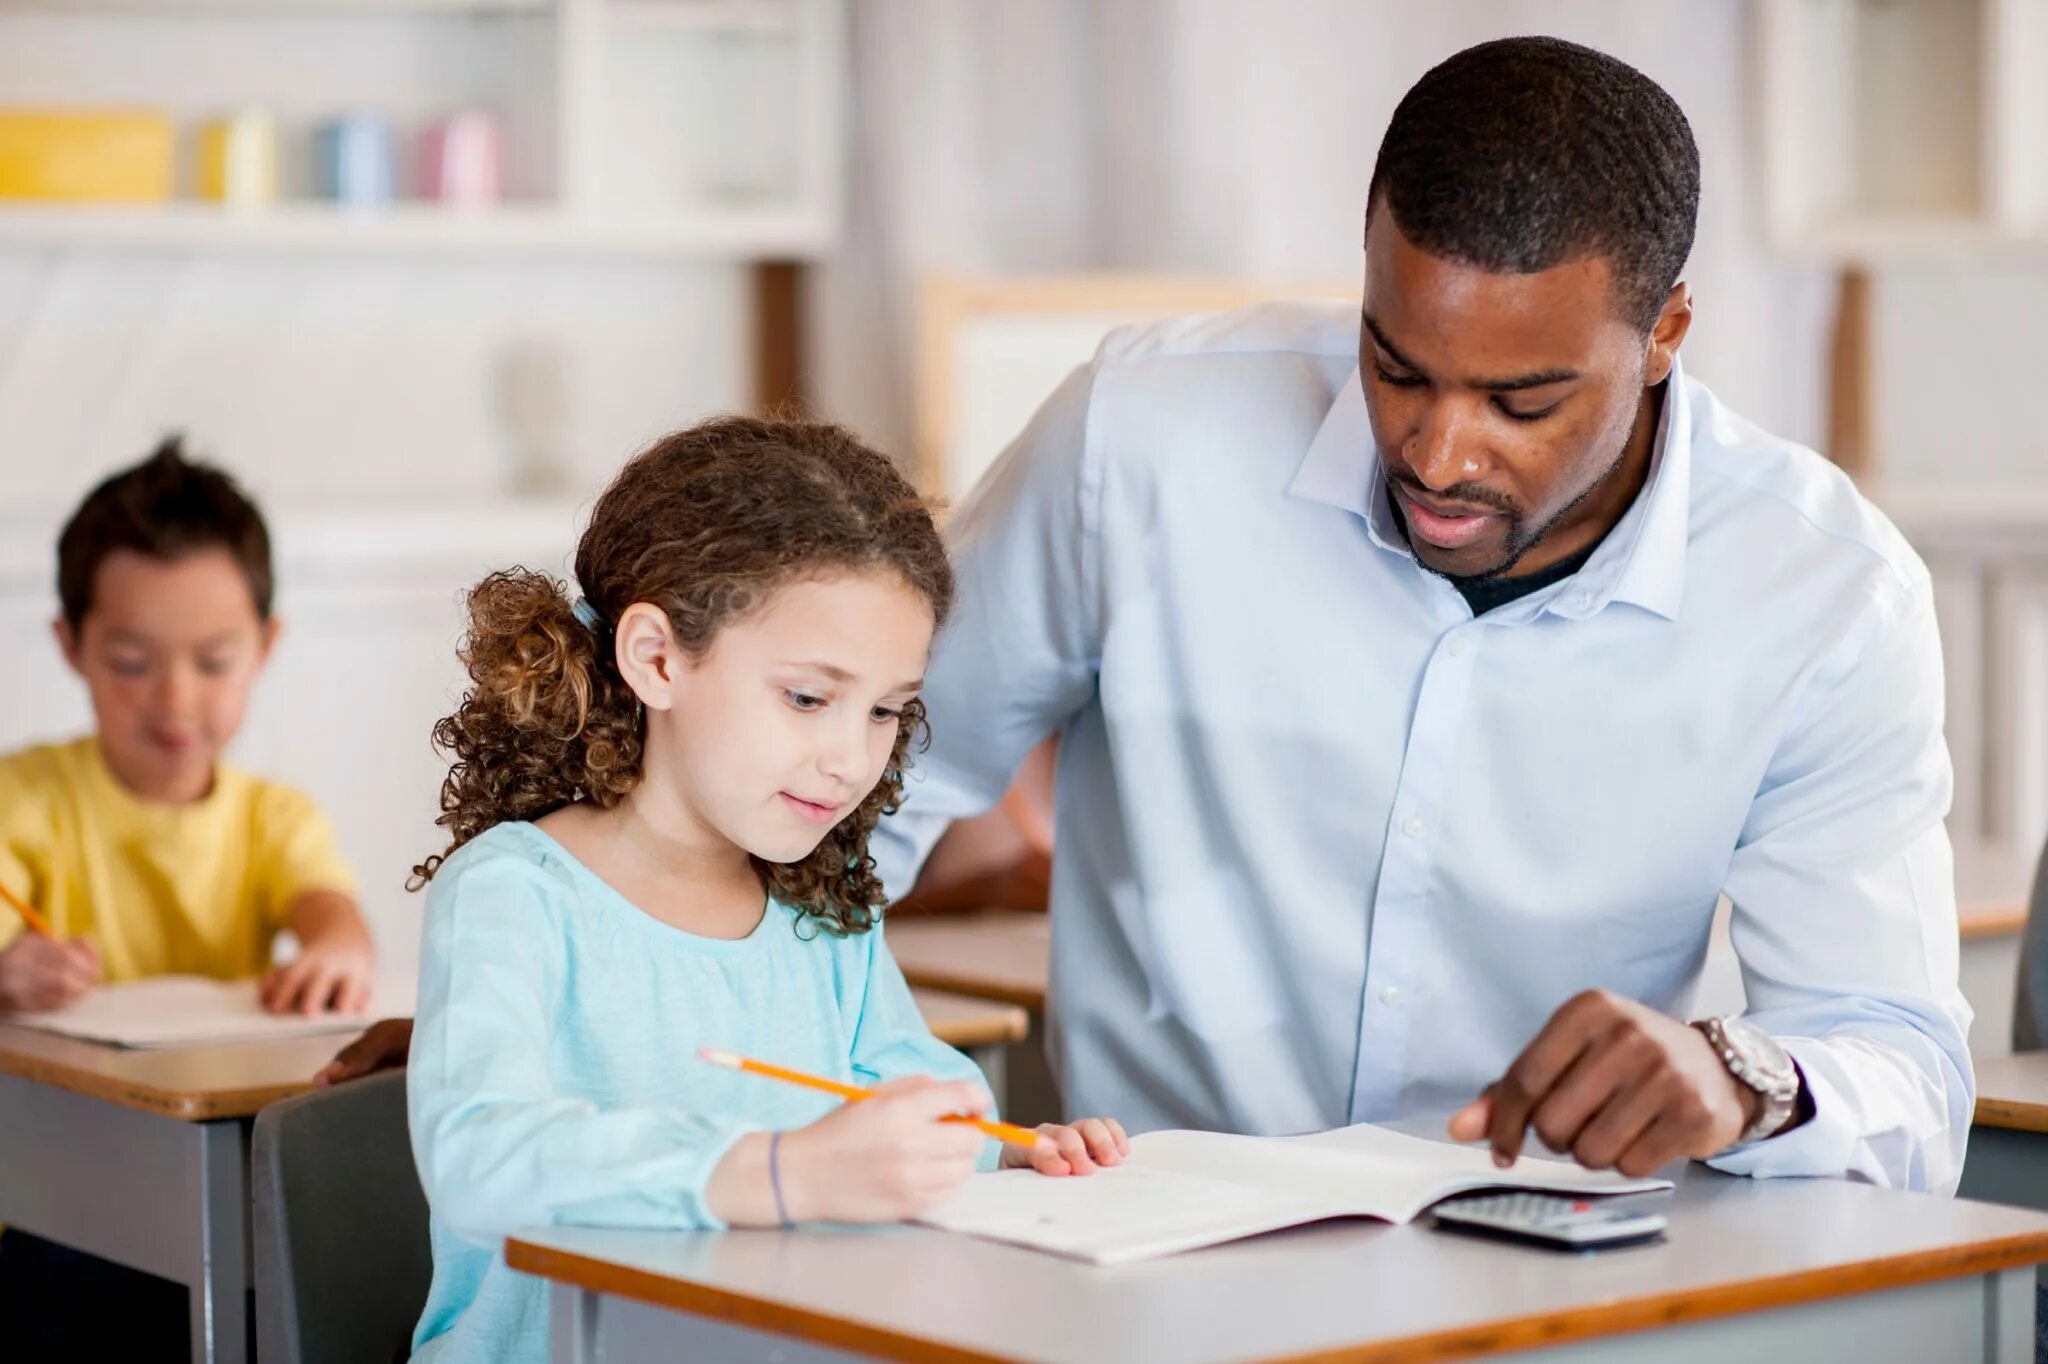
[877,305,1974,1190]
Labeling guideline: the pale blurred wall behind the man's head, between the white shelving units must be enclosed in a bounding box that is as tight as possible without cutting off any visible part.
[817,0,1833,462]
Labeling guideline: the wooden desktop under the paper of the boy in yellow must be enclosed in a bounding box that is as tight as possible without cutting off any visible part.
[0,1024,354,1122]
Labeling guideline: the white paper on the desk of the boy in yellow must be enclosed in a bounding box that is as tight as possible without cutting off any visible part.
[8,975,416,1049]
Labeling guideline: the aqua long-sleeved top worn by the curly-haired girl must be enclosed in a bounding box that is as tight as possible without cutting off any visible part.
[406,823,997,1364]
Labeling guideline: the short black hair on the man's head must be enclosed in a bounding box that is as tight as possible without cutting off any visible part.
[1366,37,1700,332]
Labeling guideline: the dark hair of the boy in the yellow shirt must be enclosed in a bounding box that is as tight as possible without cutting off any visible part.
[57,436,272,631]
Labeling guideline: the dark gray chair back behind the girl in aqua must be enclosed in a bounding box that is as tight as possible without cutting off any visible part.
[250,1071,434,1364]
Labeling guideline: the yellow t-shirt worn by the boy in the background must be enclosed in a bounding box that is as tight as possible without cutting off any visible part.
[0,737,354,981]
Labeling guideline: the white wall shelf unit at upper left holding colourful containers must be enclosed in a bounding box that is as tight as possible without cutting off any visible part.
[0,0,848,260]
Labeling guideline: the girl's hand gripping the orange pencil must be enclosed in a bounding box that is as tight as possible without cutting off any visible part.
[780,1075,989,1223]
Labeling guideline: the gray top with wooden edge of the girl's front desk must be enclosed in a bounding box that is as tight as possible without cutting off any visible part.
[506,1167,2048,1364]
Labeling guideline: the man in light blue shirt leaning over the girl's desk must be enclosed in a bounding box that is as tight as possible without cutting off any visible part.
[877,39,1972,1190]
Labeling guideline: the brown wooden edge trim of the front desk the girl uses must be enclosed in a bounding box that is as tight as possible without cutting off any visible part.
[506,1231,2048,1364]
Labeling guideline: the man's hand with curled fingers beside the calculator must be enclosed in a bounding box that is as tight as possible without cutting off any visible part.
[1450,989,1763,1176]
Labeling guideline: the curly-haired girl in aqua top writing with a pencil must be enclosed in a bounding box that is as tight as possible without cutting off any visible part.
[408,418,1128,1360]
